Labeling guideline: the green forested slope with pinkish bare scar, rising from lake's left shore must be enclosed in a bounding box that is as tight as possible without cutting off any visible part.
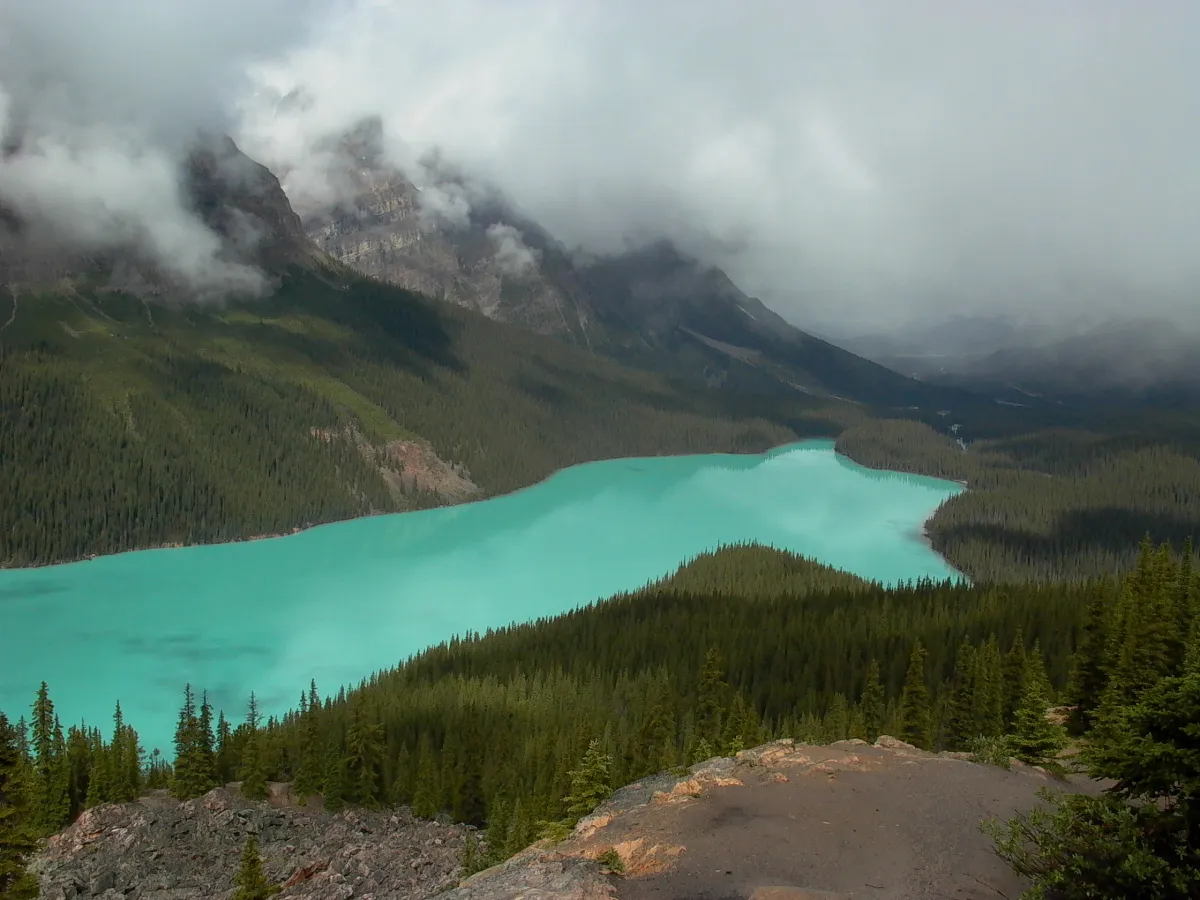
[0,264,816,565]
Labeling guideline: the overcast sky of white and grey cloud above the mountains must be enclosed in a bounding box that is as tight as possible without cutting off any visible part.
[0,0,1200,332]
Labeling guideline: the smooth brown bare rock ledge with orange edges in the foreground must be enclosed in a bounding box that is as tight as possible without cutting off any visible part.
[445,736,1089,900]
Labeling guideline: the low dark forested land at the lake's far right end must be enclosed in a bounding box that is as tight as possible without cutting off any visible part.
[838,414,1200,581]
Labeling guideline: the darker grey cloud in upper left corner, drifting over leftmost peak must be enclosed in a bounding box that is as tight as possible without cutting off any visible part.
[0,0,310,295]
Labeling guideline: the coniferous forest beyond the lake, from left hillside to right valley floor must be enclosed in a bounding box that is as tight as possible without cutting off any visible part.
[0,268,1200,582]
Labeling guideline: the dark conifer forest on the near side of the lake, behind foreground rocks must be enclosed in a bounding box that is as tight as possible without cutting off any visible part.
[0,540,1200,898]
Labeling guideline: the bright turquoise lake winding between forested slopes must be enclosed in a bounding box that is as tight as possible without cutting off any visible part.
[0,440,962,757]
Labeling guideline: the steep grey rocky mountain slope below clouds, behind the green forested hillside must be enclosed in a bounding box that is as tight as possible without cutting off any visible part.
[292,130,961,407]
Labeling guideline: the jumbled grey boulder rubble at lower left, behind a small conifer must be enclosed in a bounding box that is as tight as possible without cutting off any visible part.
[34,788,467,900]
